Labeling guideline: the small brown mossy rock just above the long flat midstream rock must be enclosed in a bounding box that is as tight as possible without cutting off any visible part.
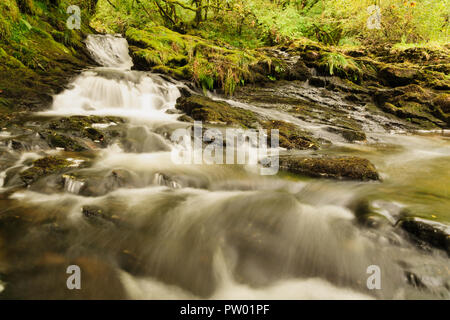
[262,120,319,150]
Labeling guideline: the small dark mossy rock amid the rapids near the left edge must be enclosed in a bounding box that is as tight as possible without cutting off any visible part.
[20,156,72,185]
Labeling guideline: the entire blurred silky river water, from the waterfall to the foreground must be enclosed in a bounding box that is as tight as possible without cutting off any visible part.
[0,36,450,299]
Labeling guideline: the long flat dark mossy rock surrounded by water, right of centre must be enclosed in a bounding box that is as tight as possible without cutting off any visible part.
[280,155,379,181]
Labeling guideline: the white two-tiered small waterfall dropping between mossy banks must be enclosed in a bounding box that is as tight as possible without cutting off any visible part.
[46,35,180,121]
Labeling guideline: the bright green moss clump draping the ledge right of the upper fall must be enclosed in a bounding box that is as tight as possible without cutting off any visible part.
[126,26,274,94]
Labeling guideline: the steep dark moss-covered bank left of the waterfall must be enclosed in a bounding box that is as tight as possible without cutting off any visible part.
[0,0,96,113]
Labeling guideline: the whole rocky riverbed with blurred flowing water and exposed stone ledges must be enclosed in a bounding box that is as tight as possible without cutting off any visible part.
[0,33,450,299]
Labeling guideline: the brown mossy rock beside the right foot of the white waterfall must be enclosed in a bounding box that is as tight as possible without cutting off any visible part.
[176,95,257,128]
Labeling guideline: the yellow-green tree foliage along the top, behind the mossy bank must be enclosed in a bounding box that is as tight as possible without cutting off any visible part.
[92,0,450,48]
